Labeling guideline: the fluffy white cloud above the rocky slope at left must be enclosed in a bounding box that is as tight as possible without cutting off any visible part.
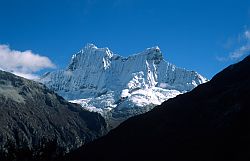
[0,44,55,79]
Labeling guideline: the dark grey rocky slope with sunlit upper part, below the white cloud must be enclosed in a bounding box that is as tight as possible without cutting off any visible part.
[0,71,106,161]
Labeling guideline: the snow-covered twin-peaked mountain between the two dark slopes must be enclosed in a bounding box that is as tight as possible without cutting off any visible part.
[40,44,207,127]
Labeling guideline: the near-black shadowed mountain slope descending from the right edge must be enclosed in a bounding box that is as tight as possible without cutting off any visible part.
[68,56,250,161]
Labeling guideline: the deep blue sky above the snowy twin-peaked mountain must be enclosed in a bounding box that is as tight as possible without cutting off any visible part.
[0,0,250,79]
